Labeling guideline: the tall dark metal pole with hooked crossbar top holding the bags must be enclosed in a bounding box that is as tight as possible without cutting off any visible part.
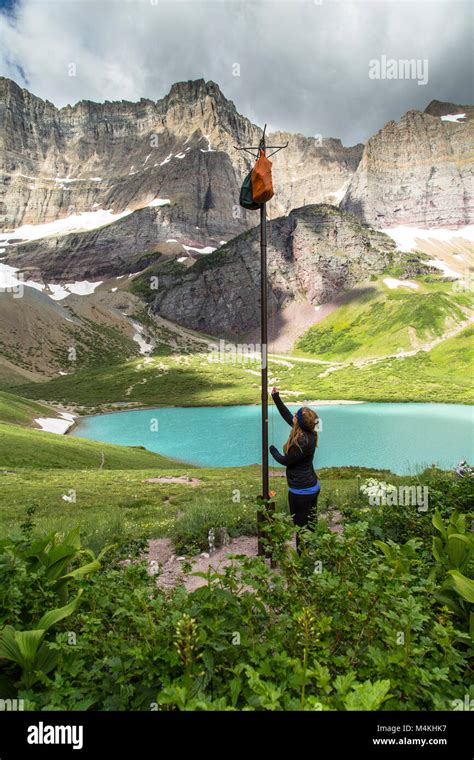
[234,124,288,556]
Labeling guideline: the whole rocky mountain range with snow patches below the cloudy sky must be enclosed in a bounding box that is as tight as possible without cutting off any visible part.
[0,78,474,382]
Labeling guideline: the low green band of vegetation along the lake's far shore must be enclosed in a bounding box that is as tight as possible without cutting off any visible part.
[10,320,474,411]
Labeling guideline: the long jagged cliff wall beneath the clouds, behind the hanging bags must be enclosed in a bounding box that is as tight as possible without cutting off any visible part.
[0,78,363,238]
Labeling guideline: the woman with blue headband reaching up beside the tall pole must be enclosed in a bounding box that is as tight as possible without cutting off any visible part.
[270,388,321,554]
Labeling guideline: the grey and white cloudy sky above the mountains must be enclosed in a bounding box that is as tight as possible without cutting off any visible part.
[0,0,474,145]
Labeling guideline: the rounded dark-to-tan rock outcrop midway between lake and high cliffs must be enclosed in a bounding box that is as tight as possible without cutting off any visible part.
[145,205,396,336]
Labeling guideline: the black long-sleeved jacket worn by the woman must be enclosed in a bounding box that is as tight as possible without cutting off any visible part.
[270,393,318,488]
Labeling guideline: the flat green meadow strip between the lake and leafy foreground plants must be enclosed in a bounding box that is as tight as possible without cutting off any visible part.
[0,464,420,549]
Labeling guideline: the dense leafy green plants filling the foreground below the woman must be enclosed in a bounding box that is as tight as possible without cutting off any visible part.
[0,469,474,711]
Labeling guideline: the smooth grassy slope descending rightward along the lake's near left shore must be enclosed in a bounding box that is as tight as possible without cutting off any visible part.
[0,422,182,470]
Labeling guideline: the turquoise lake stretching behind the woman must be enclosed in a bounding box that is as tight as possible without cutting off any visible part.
[72,403,474,474]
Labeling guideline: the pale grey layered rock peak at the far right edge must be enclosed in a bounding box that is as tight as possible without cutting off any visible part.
[341,101,474,228]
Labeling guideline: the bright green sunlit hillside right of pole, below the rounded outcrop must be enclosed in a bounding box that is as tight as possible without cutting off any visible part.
[295,277,474,362]
